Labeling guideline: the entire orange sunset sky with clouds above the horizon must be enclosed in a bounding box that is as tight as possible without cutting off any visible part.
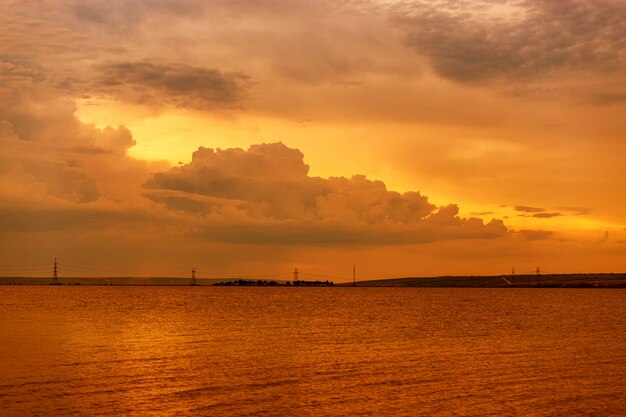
[0,0,626,282]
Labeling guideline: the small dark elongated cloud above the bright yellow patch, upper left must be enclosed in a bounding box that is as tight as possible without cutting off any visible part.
[94,61,248,109]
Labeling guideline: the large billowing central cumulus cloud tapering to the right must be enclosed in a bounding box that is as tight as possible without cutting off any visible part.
[144,143,506,244]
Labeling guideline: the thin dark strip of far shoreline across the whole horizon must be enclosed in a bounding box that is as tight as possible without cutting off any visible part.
[0,273,626,288]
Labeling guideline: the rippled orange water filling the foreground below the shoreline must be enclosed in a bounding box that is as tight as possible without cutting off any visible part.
[0,286,626,416]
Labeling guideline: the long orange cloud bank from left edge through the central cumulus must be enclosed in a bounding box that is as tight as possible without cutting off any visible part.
[0,118,507,246]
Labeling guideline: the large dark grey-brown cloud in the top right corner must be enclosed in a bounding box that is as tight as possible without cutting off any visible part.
[396,0,626,83]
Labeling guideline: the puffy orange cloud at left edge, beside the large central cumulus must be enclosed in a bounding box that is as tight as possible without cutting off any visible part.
[0,115,154,226]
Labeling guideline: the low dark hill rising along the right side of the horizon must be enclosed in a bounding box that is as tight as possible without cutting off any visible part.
[337,274,626,288]
